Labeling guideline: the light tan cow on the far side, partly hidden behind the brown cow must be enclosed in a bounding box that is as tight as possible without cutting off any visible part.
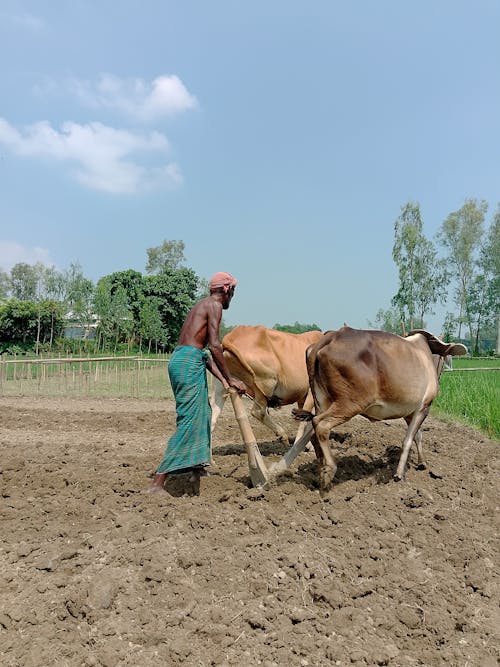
[211,325,323,444]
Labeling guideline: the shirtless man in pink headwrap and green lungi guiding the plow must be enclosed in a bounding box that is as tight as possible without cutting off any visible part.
[148,272,246,493]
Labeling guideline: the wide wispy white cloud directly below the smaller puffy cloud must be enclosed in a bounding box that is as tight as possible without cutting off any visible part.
[0,118,182,194]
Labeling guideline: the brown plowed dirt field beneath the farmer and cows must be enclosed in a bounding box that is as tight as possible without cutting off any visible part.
[0,398,500,667]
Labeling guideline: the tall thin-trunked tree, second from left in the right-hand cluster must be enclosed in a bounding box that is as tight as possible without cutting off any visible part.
[437,199,488,345]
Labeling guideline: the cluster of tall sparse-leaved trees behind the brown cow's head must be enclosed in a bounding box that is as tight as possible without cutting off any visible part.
[372,199,500,354]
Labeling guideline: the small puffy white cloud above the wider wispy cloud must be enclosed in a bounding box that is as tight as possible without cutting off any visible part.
[68,74,198,122]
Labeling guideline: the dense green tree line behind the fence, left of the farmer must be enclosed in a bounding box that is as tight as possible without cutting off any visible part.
[0,241,203,353]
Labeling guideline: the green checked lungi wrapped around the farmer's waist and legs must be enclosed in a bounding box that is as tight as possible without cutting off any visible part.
[157,345,212,474]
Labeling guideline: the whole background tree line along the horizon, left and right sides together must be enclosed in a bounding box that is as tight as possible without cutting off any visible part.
[0,199,500,353]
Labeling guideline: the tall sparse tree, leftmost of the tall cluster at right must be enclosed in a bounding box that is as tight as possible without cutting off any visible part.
[391,202,449,329]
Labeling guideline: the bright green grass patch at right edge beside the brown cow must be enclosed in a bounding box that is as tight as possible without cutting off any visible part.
[432,357,500,440]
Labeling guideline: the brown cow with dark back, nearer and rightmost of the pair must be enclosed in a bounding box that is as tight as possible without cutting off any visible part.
[294,326,467,493]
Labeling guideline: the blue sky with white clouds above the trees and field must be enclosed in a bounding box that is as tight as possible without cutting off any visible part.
[0,0,500,333]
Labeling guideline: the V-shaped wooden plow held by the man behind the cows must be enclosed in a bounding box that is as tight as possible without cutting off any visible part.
[229,388,313,488]
